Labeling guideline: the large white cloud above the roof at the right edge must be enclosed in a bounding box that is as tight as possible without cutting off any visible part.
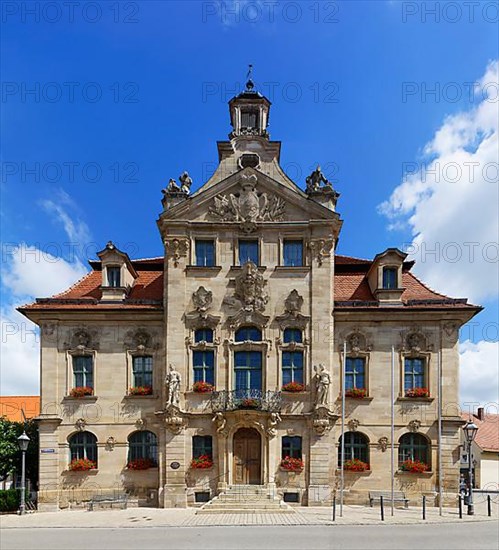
[380,61,499,303]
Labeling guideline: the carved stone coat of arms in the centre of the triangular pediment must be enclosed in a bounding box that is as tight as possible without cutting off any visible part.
[209,174,286,233]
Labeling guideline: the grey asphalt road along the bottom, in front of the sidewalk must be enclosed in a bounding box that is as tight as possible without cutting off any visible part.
[0,522,499,550]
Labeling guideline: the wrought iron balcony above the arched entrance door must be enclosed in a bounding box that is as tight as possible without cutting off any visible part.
[211,390,282,412]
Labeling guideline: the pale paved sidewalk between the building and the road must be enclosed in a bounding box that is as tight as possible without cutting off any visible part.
[0,502,499,529]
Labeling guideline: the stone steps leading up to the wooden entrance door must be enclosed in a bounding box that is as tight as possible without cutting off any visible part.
[196,485,295,514]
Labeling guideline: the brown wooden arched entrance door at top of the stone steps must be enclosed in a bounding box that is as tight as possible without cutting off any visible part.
[233,428,262,485]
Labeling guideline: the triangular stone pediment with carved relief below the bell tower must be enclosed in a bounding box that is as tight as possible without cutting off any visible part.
[159,167,339,232]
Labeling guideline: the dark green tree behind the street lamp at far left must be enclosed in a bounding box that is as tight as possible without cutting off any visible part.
[0,416,38,487]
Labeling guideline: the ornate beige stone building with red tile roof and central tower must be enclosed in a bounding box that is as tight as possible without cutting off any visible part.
[21,81,479,509]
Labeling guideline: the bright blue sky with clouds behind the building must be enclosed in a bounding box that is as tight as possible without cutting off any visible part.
[1,0,498,401]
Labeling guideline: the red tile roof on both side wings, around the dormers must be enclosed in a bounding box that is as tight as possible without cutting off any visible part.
[19,255,476,311]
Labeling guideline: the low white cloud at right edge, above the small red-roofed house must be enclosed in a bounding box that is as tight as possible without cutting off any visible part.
[459,340,499,411]
